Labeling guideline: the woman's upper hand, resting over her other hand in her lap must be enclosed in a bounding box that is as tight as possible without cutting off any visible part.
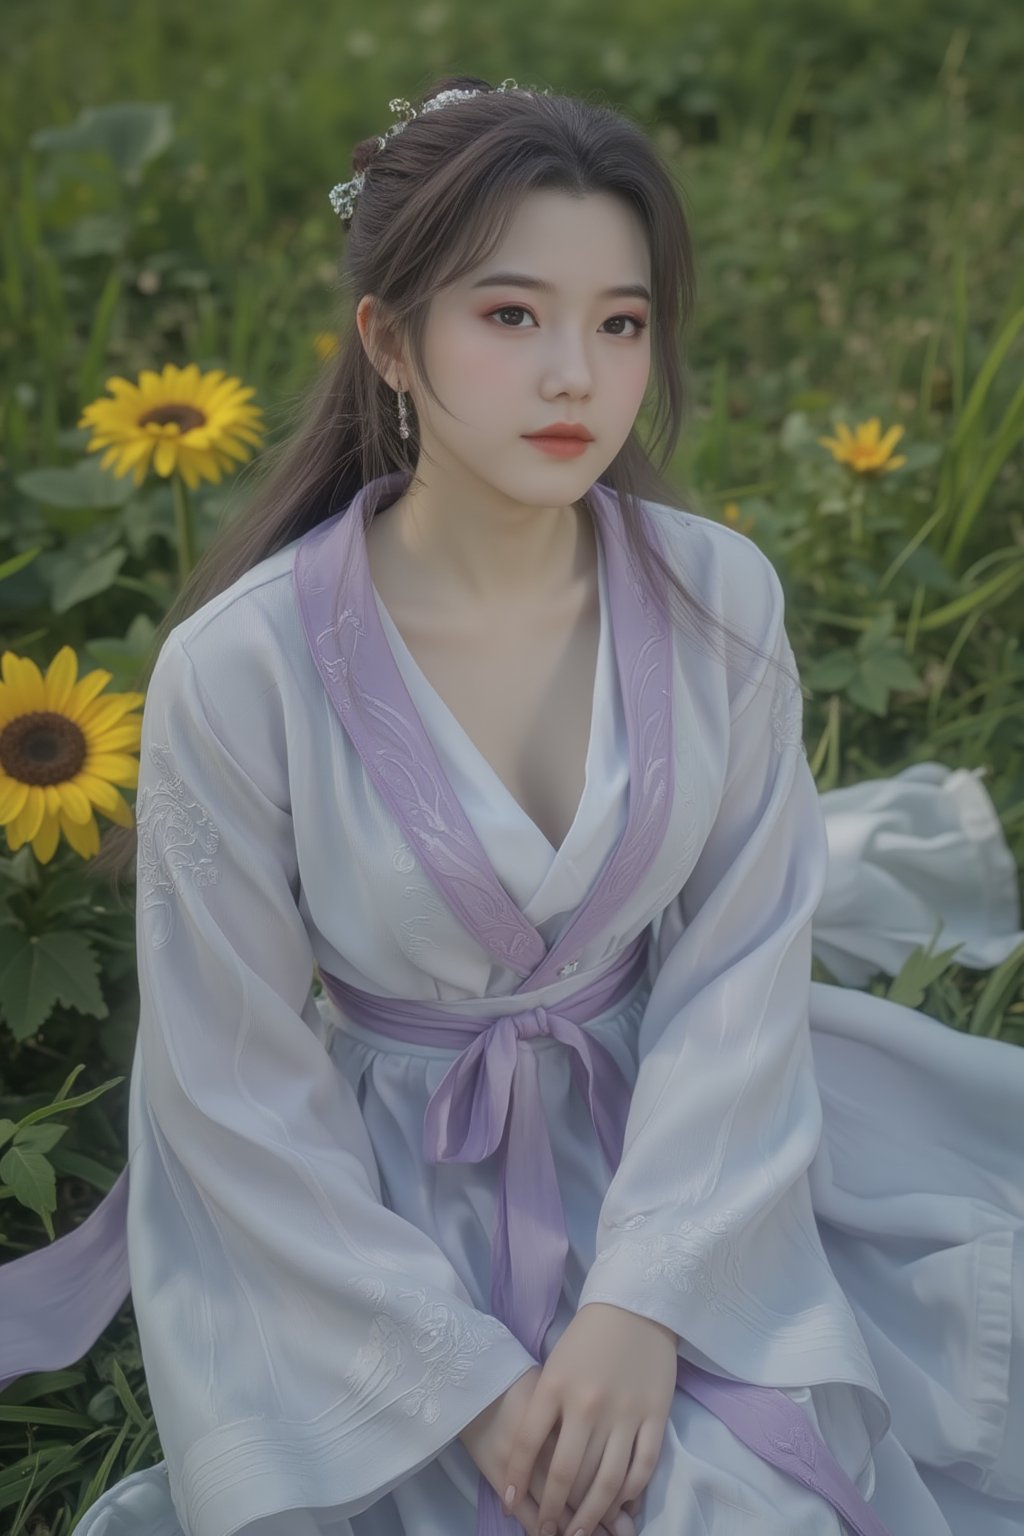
[502,1301,679,1536]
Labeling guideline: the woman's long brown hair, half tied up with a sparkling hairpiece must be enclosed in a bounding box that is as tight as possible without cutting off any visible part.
[92,75,776,886]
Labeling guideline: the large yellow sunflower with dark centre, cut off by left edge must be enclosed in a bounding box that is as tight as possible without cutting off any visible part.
[0,645,146,863]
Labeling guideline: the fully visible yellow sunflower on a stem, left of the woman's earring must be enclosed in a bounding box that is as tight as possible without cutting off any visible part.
[78,362,263,490]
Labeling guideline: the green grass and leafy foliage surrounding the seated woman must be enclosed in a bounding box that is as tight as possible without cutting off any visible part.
[0,0,1024,1536]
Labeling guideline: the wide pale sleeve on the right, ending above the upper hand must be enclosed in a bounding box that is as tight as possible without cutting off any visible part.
[579,541,878,1412]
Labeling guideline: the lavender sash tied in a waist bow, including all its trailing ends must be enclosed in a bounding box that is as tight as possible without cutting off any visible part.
[0,940,890,1536]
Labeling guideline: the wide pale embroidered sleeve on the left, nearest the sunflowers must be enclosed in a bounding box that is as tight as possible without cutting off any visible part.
[127,631,534,1536]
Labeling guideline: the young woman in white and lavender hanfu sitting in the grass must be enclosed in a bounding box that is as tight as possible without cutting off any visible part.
[0,78,1024,1536]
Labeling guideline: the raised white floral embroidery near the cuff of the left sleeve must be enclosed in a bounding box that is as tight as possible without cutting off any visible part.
[344,1275,508,1424]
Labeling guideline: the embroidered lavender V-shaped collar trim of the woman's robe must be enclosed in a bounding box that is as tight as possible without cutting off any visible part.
[295,472,672,988]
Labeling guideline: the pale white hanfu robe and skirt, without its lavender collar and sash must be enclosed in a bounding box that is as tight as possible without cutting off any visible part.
[67,478,1024,1536]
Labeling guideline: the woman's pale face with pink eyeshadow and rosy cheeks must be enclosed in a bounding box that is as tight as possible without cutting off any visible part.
[363,189,651,505]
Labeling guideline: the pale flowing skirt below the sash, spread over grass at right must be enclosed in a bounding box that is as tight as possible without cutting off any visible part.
[74,763,1024,1536]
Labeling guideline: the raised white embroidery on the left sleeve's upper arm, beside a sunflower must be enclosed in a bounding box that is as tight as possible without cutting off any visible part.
[135,742,221,949]
